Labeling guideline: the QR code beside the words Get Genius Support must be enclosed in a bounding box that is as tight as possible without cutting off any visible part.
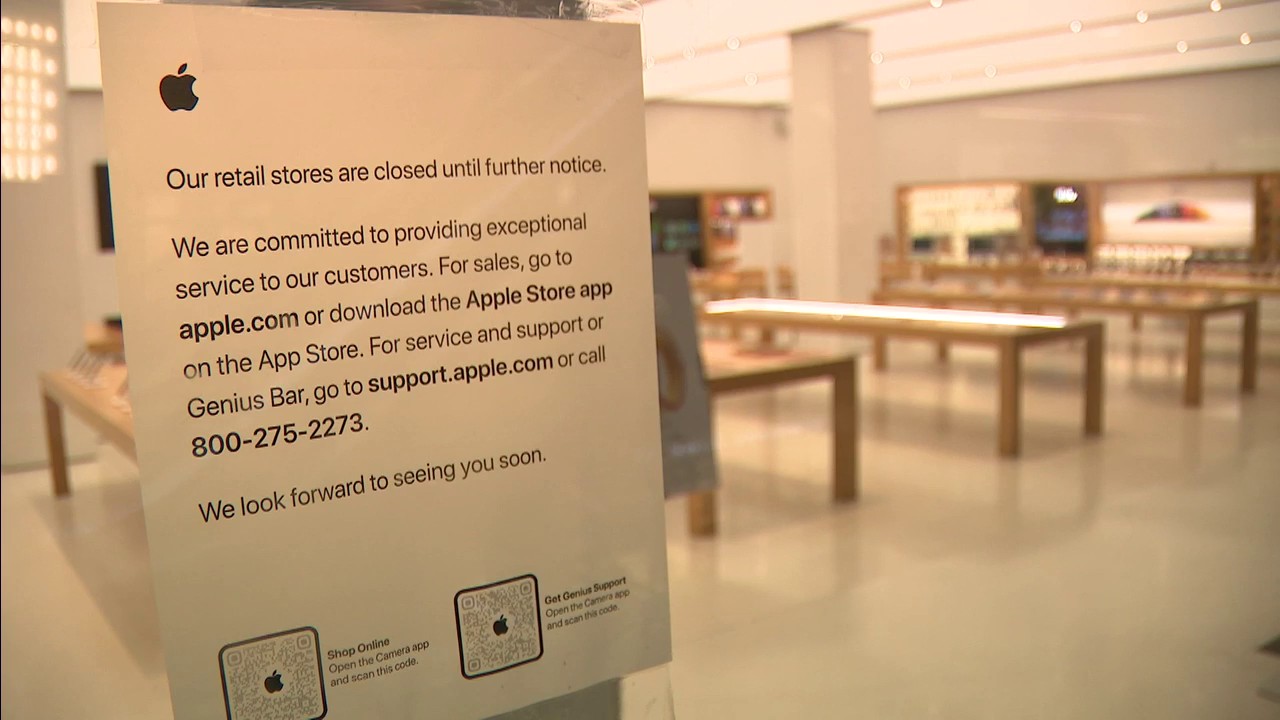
[453,575,543,678]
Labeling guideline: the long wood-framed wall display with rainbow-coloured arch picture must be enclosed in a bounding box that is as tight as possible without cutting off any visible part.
[881,174,1280,284]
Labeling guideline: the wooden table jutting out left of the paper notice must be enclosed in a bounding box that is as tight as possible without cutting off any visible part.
[40,370,137,496]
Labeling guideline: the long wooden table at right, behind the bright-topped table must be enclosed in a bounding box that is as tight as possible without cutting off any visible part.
[872,288,1258,407]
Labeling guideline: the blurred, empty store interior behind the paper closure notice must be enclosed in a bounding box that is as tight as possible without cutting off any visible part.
[0,0,1280,719]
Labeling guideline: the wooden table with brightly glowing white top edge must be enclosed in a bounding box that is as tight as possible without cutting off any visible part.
[701,300,1105,457]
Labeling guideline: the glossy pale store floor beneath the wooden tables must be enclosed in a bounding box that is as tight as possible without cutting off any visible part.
[0,306,1280,720]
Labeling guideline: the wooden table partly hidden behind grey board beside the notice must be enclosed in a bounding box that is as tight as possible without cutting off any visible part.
[689,342,858,537]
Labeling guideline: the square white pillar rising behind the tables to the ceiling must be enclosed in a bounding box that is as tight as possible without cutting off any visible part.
[787,27,879,302]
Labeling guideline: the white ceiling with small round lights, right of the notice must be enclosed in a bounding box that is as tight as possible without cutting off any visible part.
[641,0,1280,106]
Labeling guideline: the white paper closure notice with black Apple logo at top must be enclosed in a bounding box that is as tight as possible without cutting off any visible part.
[100,5,671,720]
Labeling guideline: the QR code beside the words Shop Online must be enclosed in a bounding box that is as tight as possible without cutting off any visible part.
[218,628,329,720]
